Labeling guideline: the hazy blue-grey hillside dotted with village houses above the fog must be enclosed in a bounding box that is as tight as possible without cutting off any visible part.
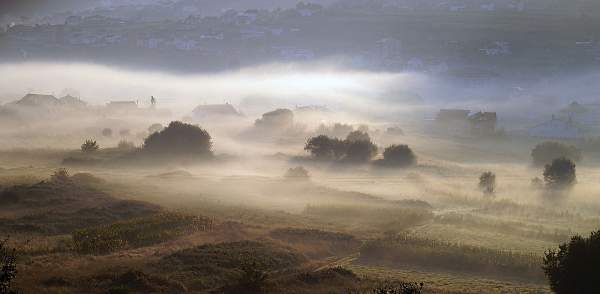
[0,0,600,76]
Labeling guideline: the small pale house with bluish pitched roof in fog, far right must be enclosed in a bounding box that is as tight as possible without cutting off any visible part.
[528,117,585,140]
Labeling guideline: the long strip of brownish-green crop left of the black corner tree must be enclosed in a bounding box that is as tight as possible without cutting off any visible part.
[360,235,543,280]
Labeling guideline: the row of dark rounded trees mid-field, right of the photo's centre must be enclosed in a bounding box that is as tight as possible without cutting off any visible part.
[304,130,417,166]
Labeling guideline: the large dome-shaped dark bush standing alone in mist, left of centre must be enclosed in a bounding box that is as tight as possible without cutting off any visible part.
[143,121,212,156]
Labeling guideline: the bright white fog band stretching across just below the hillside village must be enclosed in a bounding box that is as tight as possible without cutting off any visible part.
[0,62,600,120]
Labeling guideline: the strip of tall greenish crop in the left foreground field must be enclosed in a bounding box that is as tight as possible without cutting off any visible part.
[72,213,212,254]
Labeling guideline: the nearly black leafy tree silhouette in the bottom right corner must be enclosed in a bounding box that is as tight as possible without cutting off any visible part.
[543,231,600,294]
